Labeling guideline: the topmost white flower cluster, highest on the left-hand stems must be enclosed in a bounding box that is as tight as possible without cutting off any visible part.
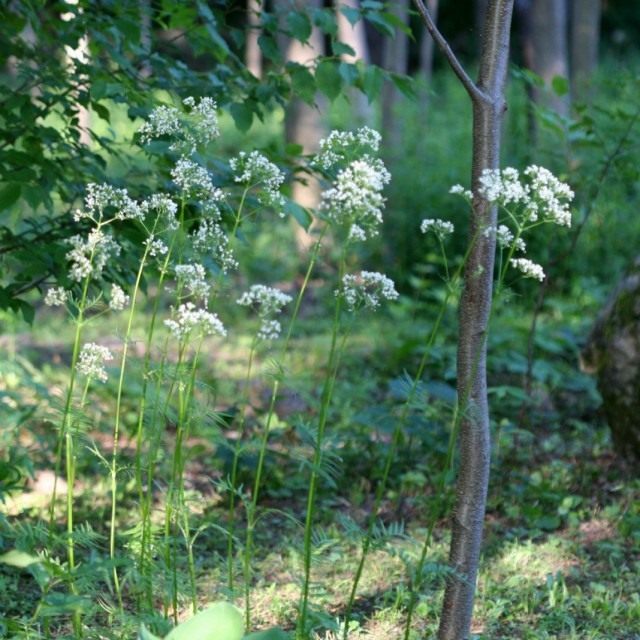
[138,97,220,154]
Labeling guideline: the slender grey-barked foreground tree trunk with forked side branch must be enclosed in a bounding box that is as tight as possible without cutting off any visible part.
[415,0,513,640]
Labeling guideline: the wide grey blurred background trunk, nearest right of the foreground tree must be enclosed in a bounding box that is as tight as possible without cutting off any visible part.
[529,0,570,116]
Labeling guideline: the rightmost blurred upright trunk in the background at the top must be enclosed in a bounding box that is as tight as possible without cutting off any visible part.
[571,0,602,101]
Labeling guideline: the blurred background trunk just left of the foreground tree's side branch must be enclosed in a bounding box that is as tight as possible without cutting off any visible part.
[382,0,409,152]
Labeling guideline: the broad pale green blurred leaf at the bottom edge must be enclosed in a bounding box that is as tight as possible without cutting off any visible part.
[165,602,244,640]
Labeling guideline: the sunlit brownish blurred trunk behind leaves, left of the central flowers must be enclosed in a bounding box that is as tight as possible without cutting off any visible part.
[276,0,324,253]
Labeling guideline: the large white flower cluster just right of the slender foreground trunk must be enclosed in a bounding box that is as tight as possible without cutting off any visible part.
[479,165,574,227]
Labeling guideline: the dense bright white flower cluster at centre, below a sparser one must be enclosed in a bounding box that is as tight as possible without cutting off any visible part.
[320,156,391,240]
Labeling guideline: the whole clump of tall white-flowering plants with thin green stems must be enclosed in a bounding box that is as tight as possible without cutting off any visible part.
[31,91,573,640]
